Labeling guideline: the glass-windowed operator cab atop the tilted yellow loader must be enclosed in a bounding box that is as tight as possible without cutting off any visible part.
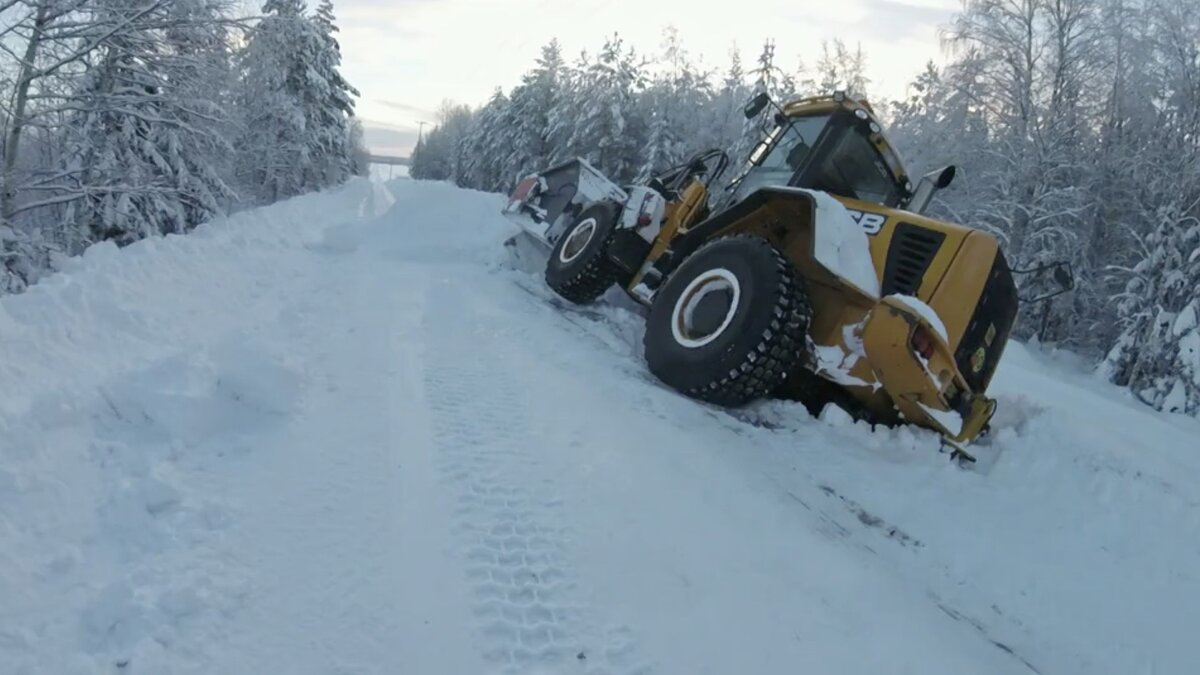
[722,95,912,208]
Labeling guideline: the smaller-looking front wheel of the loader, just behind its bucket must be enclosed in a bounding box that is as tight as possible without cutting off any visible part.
[546,202,620,305]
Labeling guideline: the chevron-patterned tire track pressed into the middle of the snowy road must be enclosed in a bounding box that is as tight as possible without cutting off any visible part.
[424,275,650,675]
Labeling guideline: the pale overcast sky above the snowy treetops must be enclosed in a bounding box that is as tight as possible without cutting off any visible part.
[335,0,960,154]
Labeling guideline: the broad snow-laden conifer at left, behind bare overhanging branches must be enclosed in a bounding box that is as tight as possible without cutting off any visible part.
[53,0,232,244]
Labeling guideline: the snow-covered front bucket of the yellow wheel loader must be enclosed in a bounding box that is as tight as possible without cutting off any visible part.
[500,159,626,255]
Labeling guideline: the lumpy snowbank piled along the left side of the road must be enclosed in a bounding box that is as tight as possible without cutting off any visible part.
[0,176,403,674]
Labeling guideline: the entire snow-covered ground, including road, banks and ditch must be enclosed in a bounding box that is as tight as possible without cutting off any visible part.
[0,181,1200,675]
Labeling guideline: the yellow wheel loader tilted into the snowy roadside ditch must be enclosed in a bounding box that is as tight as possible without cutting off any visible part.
[504,92,1069,459]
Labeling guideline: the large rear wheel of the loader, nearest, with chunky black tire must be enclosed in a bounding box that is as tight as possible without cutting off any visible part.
[643,234,812,407]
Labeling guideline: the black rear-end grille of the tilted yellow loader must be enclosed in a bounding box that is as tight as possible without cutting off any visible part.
[954,251,1018,393]
